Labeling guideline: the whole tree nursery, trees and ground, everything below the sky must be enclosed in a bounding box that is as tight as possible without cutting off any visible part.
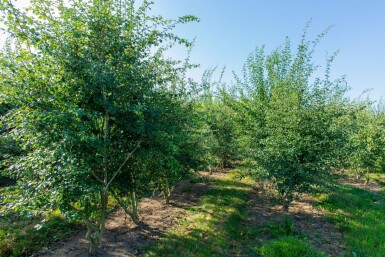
[0,0,385,257]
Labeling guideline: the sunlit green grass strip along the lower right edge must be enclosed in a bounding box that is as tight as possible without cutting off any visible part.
[317,173,385,257]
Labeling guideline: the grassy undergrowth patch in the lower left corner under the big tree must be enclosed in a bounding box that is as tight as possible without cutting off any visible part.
[0,187,116,257]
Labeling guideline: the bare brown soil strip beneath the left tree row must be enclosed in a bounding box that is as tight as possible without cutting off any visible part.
[33,173,211,257]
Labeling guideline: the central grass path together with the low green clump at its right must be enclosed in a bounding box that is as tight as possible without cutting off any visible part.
[142,169,324,257]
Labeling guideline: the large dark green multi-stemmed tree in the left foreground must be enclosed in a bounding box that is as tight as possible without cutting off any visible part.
[0,0,197,253]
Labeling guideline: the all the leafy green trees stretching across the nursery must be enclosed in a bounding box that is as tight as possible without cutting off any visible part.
[0,0,385,252]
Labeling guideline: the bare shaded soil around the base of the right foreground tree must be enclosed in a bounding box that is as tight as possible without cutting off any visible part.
[248,180,346,256]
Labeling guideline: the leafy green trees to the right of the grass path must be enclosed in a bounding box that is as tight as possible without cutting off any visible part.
[202,27,385,209]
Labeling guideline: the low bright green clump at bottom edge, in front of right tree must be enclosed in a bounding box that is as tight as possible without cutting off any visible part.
[260,236,325,257]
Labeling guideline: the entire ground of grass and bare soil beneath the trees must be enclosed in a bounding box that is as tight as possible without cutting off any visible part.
[0,169,385,257]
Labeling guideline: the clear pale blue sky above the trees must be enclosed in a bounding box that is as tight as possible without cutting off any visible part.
[0,0,385,100]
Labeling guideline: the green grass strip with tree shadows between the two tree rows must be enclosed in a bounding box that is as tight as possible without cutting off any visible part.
[143,171,256,257]
